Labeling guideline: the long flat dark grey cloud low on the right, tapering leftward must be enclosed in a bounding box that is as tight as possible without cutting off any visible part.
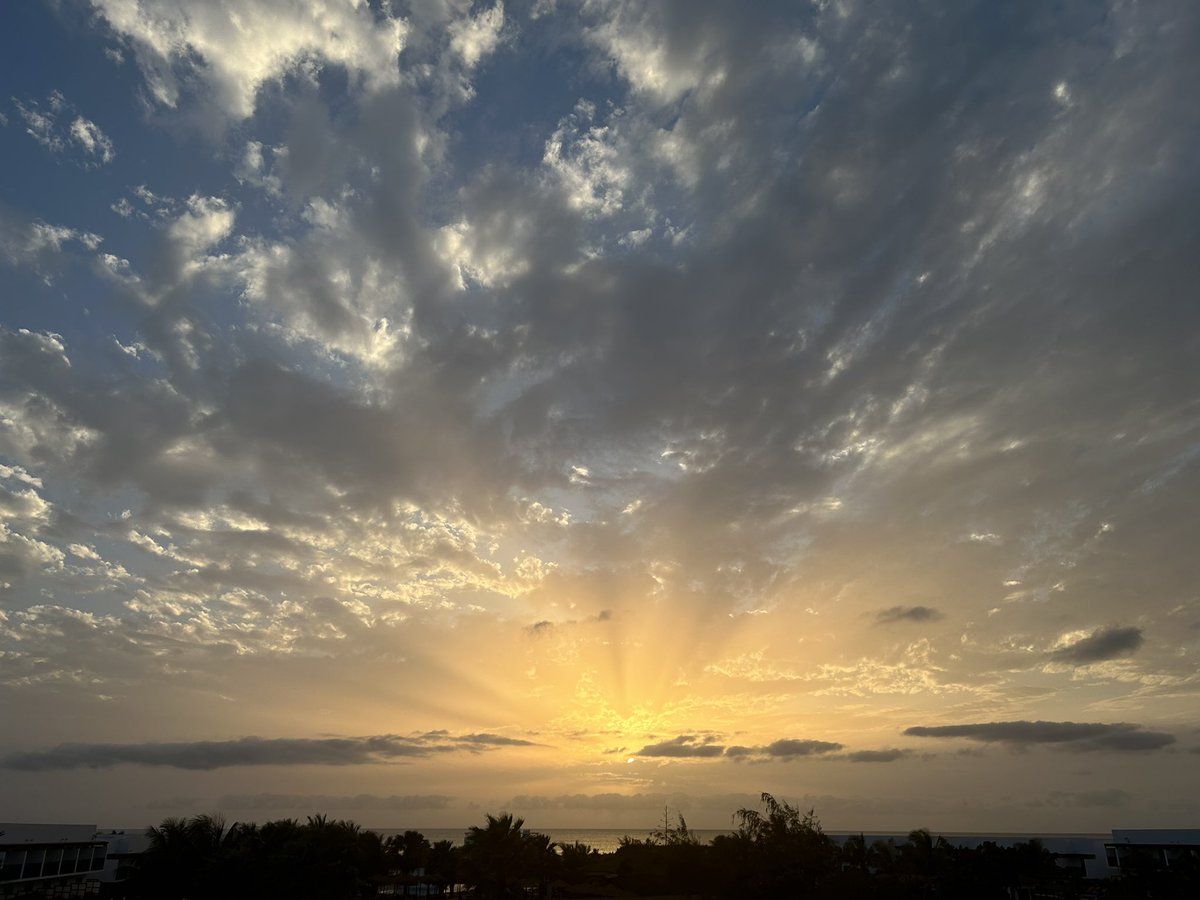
[904,721,1175,752]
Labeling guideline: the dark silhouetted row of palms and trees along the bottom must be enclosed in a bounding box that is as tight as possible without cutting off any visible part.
[112,793,1200,900]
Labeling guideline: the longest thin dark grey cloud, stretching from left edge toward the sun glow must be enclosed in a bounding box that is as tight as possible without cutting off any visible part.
[0,732,533,772]
